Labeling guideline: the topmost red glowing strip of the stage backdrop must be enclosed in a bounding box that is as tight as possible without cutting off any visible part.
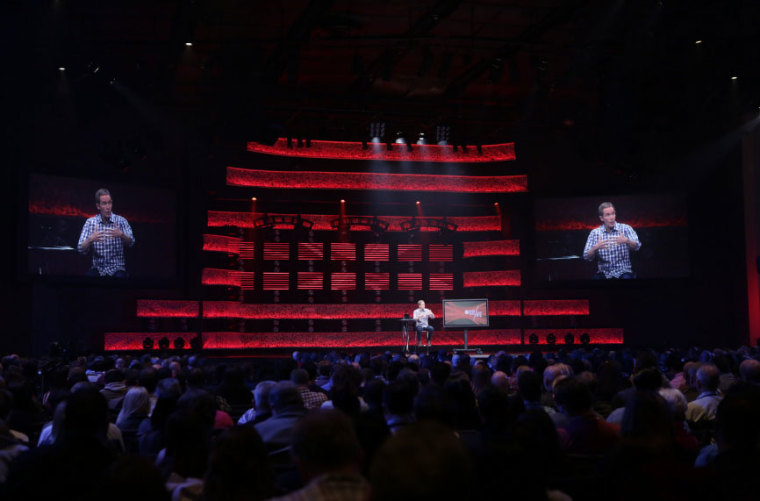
[247,137,515,163]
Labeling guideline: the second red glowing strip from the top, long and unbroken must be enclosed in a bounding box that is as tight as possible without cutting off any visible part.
[227,167,528,193]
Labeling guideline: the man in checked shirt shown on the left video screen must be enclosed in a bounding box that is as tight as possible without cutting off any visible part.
[77,188,135,278]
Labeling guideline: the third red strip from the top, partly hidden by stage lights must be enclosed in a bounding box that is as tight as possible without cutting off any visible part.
[208,211,504,233]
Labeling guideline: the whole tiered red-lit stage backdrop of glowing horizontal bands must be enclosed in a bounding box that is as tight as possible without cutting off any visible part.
[105,139,623,351]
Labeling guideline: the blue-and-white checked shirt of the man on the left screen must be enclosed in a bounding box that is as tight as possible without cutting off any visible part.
[77,214,135,276]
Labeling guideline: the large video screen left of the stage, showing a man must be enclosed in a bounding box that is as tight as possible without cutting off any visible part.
[27,174,177,282]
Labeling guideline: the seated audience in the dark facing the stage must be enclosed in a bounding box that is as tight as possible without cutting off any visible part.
[0,347,760,501]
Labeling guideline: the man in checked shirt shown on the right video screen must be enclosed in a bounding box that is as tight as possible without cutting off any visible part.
[583,202,641,279]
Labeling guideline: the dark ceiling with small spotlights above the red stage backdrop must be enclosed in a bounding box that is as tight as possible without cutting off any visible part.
[4,0,760,188]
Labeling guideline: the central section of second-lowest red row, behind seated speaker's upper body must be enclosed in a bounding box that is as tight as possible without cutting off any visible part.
[203,301,520,320]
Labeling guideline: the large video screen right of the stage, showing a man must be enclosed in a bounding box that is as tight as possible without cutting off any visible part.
[534,193,689,283]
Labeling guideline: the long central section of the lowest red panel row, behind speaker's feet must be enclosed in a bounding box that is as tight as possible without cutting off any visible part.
[203,329,521,350]
